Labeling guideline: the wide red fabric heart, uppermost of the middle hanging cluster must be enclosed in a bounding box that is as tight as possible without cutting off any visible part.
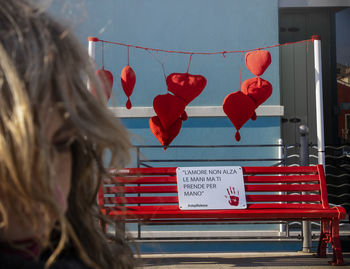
[166,73,207,104]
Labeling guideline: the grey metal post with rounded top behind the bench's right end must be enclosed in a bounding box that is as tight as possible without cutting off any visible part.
[299,125,312,253]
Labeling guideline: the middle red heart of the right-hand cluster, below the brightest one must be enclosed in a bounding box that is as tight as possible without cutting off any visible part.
[242,77,272,108]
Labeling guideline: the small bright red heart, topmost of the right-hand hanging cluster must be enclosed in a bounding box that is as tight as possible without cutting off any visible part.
[245,50,271,76]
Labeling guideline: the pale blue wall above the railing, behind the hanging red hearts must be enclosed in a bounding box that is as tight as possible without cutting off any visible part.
[53,0,280,163]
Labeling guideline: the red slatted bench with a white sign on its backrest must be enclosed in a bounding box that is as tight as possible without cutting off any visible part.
[98,165,346,265]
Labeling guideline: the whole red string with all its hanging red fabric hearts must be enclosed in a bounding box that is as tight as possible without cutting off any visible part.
[89,38,312,150]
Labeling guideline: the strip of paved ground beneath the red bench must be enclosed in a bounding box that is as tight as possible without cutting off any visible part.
[136,252,350,269]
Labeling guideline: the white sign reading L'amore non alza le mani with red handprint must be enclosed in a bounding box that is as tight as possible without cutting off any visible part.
[176,166,247,210]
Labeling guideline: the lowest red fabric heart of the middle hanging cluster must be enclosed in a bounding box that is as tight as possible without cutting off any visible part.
[149,116,182,150]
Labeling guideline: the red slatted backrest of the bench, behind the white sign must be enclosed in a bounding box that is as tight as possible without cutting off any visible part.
[99,165,329,211]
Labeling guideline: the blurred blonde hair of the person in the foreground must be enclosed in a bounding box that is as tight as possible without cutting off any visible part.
[0,0,134,268]
